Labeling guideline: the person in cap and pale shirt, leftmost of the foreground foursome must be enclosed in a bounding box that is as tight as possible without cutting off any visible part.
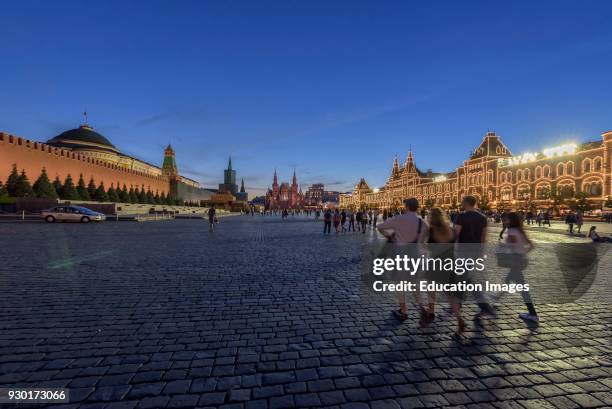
[377,198,428,321]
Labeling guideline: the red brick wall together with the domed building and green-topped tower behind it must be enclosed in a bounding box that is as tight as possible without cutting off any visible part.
[0,125,213,202]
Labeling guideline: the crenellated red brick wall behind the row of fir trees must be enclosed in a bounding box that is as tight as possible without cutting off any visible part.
[0,132,170,194]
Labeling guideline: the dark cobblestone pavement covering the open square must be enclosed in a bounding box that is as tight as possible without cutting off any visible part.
[0,216,612,409]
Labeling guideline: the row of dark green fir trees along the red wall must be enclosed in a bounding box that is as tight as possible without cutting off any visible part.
[0,165,183,205]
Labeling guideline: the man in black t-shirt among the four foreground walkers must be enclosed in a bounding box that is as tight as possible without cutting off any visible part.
[455,196,495,321]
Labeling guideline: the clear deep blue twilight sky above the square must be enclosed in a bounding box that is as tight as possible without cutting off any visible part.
[0,0,612,193]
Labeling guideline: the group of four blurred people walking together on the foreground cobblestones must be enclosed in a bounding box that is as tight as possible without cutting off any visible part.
[377,196,539,335]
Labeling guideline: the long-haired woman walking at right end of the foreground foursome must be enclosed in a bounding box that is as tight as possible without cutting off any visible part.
[505,212,539,322]
